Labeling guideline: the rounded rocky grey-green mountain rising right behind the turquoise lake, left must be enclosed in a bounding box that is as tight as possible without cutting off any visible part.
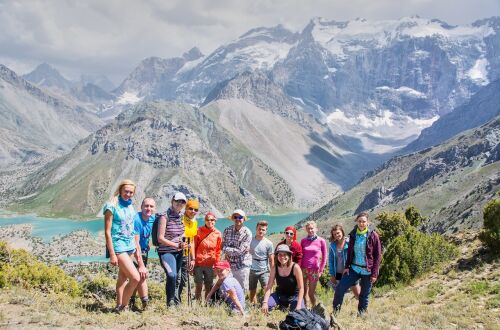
[12,103,294,217]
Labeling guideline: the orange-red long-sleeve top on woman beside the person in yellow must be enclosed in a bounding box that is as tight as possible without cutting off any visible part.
[194,226,222,267]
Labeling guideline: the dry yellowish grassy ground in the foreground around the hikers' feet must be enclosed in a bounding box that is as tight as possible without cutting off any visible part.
[0,234,500,329]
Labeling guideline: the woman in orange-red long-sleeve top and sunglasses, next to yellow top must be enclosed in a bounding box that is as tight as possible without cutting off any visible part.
[194,212,222,301]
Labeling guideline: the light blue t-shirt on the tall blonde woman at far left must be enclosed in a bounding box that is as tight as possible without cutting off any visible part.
[102,202,136,253]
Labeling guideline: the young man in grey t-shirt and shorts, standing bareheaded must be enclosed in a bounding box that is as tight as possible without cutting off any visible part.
[248,220,274,304]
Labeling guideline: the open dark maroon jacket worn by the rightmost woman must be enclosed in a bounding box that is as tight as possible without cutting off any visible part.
[345,227,382,277]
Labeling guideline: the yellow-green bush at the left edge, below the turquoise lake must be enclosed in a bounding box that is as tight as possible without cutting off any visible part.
[0,242,81,297]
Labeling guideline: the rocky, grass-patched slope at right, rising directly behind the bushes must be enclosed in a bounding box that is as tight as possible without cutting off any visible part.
[304,116,500,233]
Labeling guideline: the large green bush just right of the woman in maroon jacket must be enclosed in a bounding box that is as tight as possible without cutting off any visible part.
[377,227,458,286]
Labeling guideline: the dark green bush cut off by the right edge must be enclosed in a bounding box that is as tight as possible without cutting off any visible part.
[479,198,500,256]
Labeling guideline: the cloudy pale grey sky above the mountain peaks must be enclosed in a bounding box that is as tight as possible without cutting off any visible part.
[0,0,500,85]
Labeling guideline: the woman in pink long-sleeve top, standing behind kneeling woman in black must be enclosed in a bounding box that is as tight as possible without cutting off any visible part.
[300,221,327,307]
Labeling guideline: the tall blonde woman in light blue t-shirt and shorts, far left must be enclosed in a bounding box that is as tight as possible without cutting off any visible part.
[102,180,148,313]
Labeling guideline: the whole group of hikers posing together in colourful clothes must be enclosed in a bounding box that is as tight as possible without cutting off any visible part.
[103,180,382,317]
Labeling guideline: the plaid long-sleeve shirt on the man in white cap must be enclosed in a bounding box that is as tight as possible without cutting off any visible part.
[222,225,252,269]
